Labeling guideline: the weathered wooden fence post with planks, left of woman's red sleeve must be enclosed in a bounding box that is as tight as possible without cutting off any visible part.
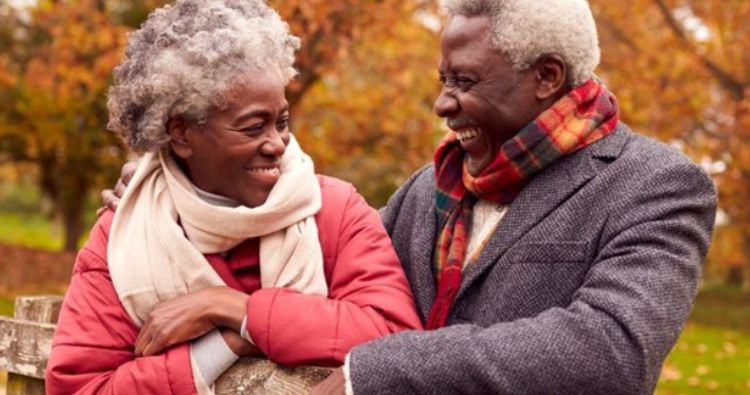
[0,295,62,395]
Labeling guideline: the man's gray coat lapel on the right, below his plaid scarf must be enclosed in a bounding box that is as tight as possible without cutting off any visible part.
[455,125,629,301]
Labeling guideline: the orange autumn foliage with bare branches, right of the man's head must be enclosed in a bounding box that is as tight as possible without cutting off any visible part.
[591,0,750,286]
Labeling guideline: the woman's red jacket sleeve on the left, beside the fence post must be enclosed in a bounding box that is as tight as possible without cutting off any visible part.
[46,213,196,394]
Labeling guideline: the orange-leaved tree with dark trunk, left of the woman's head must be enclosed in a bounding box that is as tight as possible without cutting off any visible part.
[0,0,125,250]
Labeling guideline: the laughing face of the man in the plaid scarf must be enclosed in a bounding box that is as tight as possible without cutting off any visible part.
[434,15,539,176]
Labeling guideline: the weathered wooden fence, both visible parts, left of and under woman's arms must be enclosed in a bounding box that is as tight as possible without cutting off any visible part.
[0,295,330,395]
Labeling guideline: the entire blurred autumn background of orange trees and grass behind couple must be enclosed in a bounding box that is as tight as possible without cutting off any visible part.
[0,0,750,394]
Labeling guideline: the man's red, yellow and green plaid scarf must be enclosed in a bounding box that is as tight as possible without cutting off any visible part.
[426,79,618,329]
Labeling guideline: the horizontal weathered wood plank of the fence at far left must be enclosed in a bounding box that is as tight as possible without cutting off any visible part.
[0,317,55,379]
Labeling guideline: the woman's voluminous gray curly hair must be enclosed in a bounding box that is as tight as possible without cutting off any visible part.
[107,0,299,151]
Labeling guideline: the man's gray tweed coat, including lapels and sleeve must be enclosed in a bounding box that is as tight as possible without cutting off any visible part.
[350,124,716,395]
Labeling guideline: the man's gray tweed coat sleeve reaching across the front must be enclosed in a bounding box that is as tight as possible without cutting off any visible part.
[350,165,716,394]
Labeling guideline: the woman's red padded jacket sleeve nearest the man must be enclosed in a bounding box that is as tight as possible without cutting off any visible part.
[247,184,421,366]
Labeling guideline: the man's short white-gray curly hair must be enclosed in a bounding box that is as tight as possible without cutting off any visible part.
[442,0,600,87]
